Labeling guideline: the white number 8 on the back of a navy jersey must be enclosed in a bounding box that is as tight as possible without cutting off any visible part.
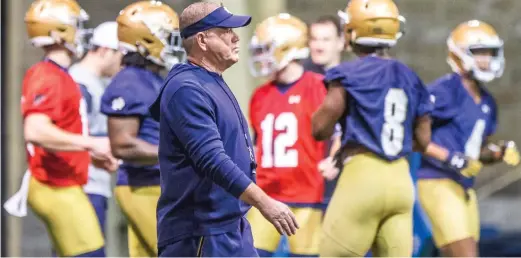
[381,88,408,156]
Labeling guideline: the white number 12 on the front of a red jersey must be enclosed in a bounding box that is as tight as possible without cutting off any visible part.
[261,112,298,168]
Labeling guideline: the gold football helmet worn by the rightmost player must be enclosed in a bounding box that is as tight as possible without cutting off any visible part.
[447,20,505,82]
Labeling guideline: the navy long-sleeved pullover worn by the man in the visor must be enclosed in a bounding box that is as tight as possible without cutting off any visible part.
[150,63,255,247]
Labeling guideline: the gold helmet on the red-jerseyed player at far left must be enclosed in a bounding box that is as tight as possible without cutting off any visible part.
[25,0,89,56]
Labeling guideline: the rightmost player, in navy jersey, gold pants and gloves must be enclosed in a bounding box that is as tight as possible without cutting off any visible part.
[418,20,519,257]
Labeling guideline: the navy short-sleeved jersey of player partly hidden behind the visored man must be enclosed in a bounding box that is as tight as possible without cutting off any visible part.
[101,66,163,186]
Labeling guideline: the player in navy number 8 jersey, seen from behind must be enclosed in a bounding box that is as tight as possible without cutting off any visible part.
[312,0,432,257]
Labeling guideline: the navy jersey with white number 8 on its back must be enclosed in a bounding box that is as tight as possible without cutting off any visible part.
[324,55,432,160]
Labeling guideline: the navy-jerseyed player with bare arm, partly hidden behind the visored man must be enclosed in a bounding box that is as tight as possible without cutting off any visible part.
[101,1,184,257]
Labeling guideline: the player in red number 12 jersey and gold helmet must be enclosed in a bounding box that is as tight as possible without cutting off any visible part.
[248,13,338,256]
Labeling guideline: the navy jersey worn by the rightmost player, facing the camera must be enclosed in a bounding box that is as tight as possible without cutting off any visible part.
[418,73,497,186]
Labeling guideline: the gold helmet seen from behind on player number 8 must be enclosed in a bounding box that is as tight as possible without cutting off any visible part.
[338,0,405,47]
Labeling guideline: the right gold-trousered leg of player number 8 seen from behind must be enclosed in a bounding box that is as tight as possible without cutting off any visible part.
[371,155,414,257]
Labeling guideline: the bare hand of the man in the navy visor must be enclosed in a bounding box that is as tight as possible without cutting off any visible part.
[258,198,299,236]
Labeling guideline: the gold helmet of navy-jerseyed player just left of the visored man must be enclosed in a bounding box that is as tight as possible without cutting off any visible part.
[116,1,186,68]
